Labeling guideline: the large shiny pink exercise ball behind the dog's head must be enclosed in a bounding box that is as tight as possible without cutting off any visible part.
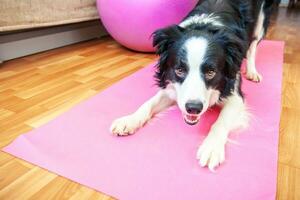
[97,0,198,52]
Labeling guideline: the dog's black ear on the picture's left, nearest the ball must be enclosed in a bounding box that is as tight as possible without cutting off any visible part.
[152,25,185,55]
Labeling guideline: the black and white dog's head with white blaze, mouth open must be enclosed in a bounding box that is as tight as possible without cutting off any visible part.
[153,25,245,125]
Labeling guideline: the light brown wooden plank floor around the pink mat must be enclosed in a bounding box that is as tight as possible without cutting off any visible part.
[0,6,300,200]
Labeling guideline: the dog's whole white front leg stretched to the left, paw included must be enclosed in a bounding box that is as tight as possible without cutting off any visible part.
[110,89,175,136]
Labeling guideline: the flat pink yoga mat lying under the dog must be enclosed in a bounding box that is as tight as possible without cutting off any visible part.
[4,41,284,200]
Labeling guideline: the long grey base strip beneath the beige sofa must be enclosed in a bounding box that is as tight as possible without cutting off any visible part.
[0,22,107,63]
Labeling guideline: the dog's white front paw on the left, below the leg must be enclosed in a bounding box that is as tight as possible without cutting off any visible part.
[110,115,143,136]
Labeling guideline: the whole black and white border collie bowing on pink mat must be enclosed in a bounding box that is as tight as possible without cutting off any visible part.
[111,0,273,170]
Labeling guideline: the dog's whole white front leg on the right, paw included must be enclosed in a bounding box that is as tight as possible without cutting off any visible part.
[197,93,248,171]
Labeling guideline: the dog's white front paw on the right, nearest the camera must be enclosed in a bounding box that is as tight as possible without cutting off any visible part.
[197,136,226,171]
